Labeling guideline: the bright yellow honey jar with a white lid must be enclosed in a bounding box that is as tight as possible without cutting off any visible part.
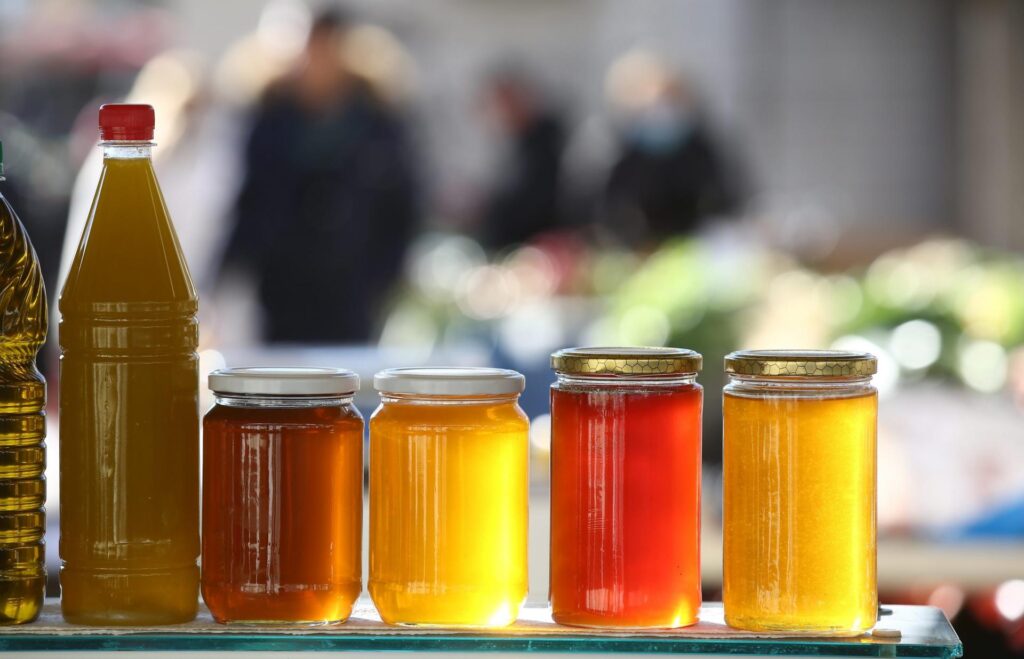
[369,368,529,627]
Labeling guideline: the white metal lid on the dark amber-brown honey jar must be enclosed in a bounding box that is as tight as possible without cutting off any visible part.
[210,366,359,396]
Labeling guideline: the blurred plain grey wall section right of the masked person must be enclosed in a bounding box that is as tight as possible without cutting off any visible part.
[737,0,953,230]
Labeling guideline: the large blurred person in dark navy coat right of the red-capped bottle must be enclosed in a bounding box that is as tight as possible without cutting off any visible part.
[223,10,418,344]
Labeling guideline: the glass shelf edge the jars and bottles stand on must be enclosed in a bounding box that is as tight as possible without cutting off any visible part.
[0,599,964,659]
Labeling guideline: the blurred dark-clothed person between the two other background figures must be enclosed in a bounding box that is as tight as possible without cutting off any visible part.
[480,67,565,250]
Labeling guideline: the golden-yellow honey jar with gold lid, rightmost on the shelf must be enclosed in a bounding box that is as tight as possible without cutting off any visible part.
[722,350,878,635]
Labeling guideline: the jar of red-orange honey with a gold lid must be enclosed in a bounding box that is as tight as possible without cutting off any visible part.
[551,348,702,628]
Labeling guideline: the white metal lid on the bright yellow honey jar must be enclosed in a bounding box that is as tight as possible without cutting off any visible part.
[374,366,526,396]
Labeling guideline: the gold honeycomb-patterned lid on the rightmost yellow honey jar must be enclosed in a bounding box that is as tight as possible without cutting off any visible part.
[725,350,879,378]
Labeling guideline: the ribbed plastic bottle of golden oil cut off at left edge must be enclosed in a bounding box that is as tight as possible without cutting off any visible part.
[0,139,46,624]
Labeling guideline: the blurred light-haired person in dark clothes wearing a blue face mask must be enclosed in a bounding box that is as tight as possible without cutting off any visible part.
[601,51,738,248]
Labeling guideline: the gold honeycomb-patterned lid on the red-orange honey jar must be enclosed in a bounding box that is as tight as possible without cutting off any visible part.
[551,348,702,376]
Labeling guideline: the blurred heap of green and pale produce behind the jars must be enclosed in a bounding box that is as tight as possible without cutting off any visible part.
[382,231,1024,397]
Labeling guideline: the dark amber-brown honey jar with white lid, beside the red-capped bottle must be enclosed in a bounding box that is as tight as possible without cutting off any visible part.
[202,368,362,624]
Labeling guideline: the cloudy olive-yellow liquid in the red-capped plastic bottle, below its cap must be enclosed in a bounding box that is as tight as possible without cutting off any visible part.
[60,145,199,625]
